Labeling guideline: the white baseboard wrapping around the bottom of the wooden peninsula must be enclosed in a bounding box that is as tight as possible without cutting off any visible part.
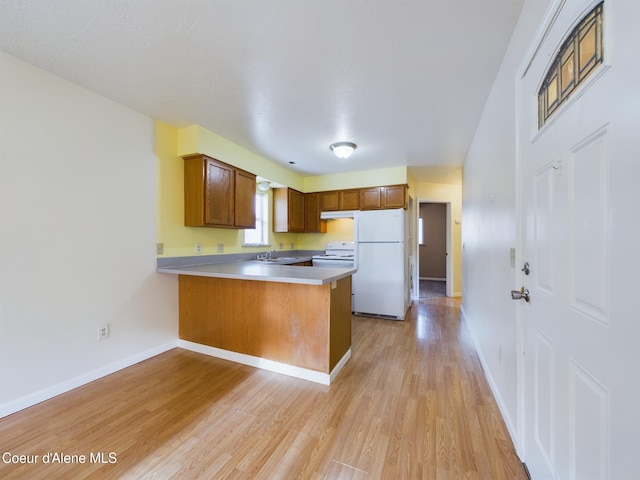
[178,340,351,385]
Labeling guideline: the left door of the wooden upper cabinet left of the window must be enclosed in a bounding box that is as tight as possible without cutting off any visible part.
[204,158,235,227]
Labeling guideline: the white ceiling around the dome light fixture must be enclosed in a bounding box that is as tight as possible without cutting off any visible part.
[0,0,523,180]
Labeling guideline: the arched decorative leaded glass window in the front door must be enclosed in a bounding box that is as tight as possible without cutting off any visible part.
[538,2,604,128]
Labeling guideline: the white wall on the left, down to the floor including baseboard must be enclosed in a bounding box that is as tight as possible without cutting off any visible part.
[0,52,177,416]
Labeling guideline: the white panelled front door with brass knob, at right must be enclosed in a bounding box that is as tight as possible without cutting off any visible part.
[518,0,640,480]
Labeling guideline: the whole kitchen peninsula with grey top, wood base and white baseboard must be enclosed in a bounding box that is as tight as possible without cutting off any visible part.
[157,260,356,384]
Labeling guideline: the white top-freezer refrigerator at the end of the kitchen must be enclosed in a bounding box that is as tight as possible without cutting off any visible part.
[353,208,410,320]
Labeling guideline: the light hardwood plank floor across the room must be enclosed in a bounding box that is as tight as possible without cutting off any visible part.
[0,297,526,480]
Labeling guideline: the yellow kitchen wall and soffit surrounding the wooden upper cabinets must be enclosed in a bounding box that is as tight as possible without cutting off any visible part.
[156,122,430,257]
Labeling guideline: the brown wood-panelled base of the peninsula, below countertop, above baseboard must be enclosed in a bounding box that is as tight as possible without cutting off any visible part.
[178,275,351,374]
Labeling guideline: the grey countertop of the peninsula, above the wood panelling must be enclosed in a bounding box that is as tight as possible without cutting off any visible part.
[157,260,357,285]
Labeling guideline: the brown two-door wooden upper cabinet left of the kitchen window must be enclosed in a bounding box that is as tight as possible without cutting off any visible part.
[184,154,256,228]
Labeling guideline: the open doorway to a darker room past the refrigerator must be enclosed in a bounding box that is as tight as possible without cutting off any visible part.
[417,202,448,299]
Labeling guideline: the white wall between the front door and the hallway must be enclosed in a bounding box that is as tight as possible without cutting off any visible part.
[462,0,550,441]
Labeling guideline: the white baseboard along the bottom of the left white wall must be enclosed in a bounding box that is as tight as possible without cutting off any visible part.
[0,341,177,418]
